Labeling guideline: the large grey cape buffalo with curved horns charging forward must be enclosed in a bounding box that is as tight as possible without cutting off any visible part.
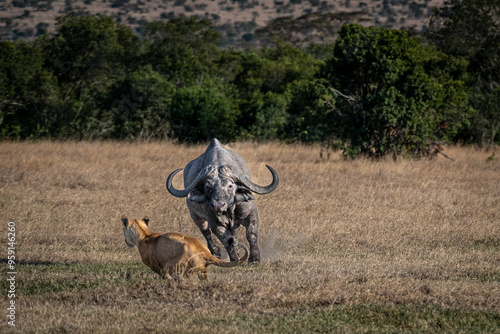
[167,139,279,263]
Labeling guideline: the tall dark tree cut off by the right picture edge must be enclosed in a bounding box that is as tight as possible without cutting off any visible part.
[426,0,500,148]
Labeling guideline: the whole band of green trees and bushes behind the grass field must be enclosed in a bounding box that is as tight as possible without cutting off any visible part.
[0,0,500,157]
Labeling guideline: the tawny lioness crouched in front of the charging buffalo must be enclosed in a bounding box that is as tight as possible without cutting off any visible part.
[122,216,249,280]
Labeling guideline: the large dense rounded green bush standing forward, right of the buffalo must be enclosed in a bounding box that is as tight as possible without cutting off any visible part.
[322,25,470,157]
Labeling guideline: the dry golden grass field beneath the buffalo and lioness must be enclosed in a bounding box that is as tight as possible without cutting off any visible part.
[0,142,500,333]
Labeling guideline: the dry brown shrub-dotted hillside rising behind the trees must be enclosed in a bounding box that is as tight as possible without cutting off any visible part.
[0,0,444,38]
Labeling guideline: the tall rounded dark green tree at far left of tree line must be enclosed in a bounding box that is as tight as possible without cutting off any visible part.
[36,15,141,139]
